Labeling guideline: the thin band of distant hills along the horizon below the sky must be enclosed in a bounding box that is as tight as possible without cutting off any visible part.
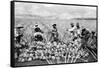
[15,14,97,20]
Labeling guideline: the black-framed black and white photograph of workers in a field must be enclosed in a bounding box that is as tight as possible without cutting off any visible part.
[11,1,98,67]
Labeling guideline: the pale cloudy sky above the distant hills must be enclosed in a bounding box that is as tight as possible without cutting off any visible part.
[15,2,96,19]
